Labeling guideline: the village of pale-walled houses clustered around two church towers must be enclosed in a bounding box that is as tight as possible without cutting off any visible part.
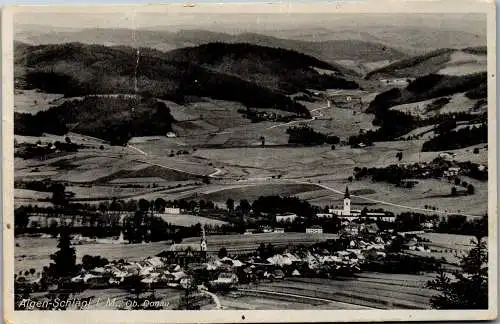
[15,182,482,309]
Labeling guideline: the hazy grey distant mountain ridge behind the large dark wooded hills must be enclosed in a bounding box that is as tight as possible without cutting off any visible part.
[16,29,406,72]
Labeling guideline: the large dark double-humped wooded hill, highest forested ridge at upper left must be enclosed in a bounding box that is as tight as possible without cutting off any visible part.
[15,43,358,117]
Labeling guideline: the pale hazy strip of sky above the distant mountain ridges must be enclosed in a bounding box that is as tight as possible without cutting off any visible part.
[14,10,486,35]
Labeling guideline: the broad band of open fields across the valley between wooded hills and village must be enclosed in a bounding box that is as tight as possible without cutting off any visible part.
[15,128,488,215]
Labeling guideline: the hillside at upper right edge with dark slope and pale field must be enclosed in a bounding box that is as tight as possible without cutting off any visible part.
[365,46,487,79]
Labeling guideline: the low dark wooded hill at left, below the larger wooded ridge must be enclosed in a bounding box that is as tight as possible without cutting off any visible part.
[14,96,174,145]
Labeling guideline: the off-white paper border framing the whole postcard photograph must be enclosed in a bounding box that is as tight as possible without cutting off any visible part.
[1,0,498,324]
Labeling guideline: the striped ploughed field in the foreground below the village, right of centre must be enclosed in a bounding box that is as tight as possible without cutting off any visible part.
[230,273,436,309]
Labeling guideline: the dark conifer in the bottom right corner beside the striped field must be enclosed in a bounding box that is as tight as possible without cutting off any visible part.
[427,235,488,309]
